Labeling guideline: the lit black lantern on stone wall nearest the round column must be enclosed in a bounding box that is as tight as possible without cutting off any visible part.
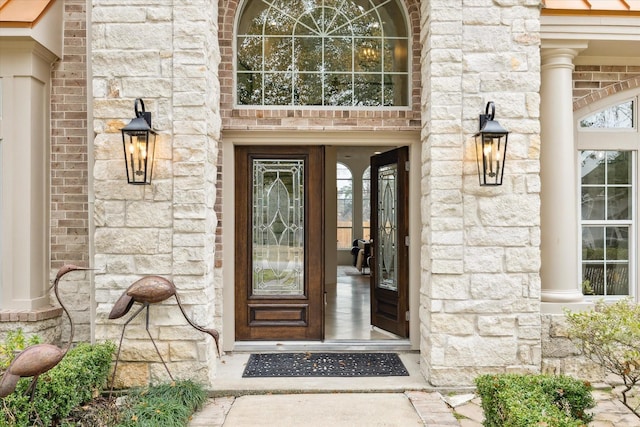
[474,101,509,186]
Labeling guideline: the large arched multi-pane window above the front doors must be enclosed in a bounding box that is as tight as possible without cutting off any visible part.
[236,0,409,107]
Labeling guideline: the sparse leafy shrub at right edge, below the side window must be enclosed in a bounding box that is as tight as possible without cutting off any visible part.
[566,299,640,414]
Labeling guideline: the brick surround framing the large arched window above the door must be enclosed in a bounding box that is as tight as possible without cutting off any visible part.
[218,0,421,131]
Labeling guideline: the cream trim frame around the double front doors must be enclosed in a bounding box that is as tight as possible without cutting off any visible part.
[216,130,426,351]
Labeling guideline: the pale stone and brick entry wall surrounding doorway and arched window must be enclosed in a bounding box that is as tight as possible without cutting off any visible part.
[87,0,541,386]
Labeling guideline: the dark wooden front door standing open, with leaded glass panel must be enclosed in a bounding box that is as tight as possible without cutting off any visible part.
[371,147,409,337]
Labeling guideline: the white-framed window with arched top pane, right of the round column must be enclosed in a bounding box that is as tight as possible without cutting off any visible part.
[577,98,640,299]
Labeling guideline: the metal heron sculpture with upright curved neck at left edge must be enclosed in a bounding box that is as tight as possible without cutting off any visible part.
[0,264,92,399]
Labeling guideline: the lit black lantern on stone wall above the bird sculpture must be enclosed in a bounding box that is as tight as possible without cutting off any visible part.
[121,98,157,185]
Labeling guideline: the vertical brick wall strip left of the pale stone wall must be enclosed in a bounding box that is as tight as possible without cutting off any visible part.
[51,0,89,269]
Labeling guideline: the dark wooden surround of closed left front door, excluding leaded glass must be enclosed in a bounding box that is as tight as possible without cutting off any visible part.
[234,145,325,340]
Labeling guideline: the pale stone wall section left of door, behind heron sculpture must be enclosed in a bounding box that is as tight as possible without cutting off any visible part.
[91,0,221,386]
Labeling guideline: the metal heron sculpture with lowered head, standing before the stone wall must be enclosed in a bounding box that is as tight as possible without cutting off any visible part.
[109,276,220,389]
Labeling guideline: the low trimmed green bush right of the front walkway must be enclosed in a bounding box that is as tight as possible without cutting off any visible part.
[475,374,595,427]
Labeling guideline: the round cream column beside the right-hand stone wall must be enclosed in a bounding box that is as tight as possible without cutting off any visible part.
[540,45,586,303]
